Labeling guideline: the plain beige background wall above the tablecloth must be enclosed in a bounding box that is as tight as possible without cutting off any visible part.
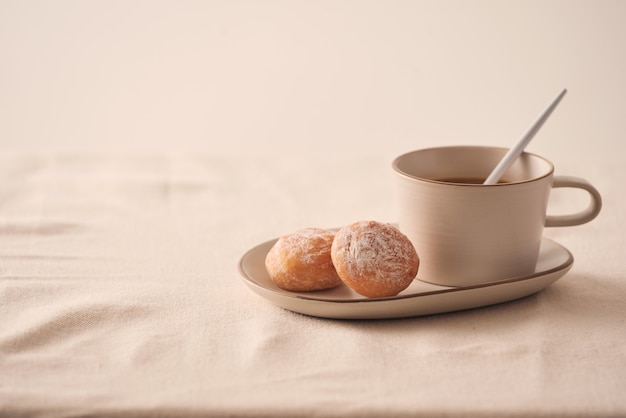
[0,0,626,164]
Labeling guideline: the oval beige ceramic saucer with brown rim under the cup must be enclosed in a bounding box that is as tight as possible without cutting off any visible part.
[239,238,574,319]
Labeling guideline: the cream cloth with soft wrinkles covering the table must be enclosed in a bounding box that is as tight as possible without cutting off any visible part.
[0,153,626,417]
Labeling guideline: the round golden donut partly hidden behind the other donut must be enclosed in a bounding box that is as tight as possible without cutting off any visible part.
[265,228,342,292]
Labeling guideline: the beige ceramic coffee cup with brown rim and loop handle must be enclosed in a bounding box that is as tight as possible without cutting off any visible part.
[393,146,602,286]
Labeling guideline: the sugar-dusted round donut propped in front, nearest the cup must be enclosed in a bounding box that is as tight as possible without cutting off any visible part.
[331,221,419,298]
